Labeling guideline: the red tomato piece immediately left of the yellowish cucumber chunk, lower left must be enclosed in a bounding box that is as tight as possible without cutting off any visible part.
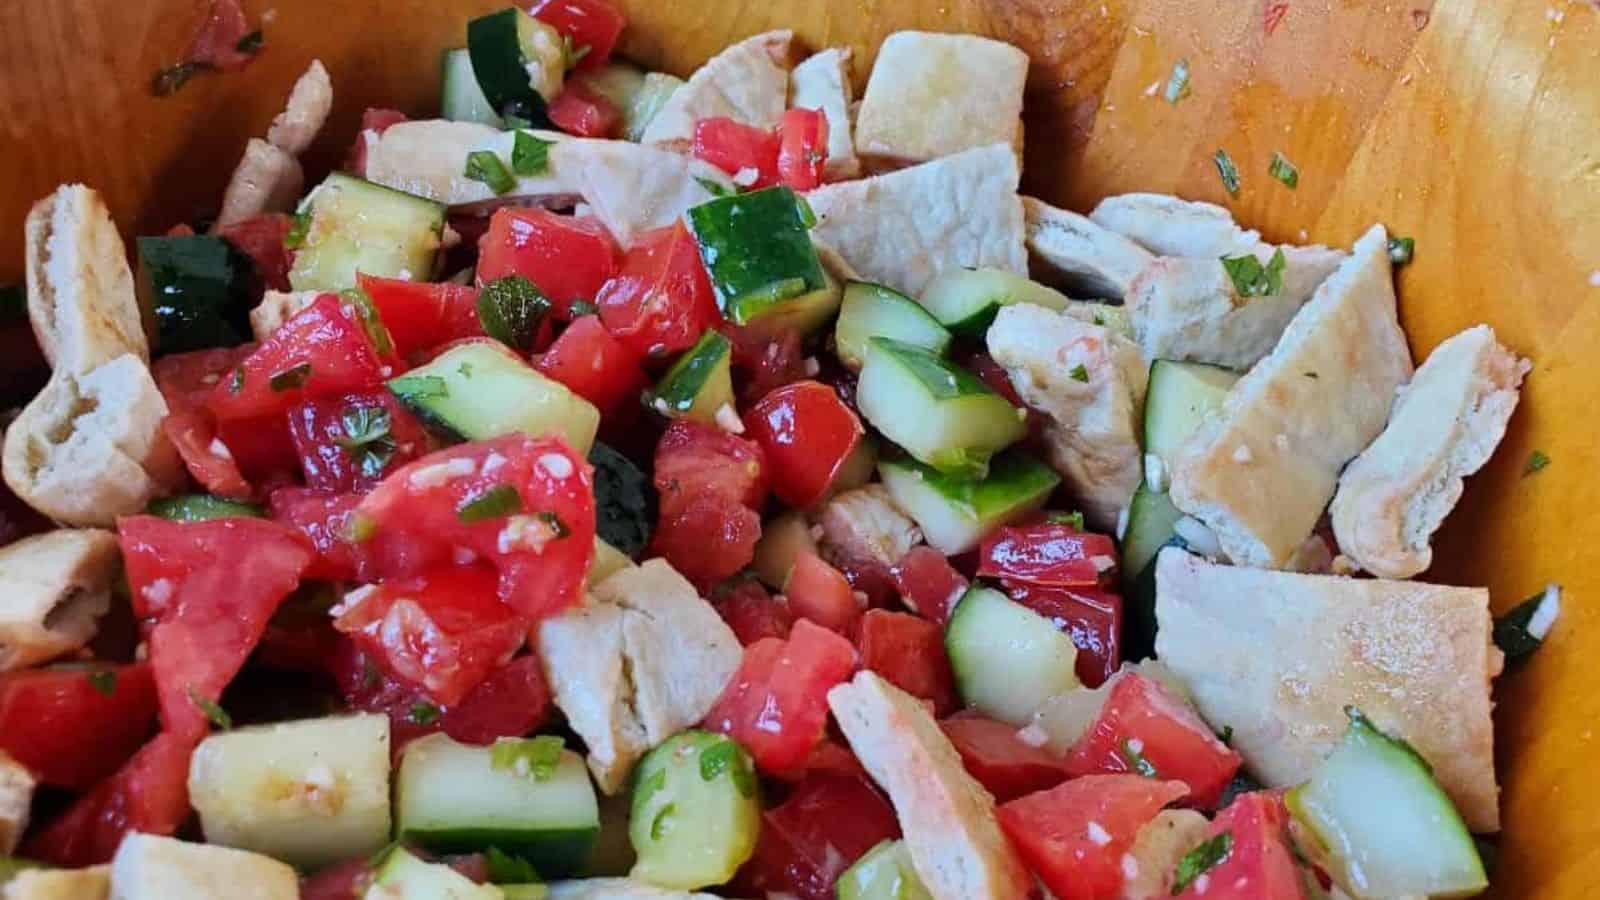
[22,733,197,868]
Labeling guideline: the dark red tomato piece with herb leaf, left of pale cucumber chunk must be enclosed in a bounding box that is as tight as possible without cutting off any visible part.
[288,391,427,492]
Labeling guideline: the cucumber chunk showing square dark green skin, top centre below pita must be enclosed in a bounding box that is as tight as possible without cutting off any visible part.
[688,187,827,325]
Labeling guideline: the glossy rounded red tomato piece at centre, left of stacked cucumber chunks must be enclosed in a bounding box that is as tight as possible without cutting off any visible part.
[744,381,866,509]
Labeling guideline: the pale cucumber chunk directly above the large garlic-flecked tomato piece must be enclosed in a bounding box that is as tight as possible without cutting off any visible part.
[389,340,600,455]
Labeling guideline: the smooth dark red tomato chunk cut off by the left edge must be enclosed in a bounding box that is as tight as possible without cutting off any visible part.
[0,663,155,791]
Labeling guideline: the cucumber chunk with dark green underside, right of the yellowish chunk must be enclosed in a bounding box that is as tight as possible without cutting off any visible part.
[395,733,600,876]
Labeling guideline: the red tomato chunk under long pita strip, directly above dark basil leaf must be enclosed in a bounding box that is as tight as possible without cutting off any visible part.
[478,207,616,322]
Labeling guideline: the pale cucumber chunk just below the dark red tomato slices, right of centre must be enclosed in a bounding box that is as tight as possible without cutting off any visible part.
[944,585,1082,727]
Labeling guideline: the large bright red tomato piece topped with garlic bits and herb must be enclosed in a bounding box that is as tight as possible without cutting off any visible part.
[354,434,595,620]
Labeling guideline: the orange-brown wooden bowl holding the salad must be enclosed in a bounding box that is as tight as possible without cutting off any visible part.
[0,0,1600,900]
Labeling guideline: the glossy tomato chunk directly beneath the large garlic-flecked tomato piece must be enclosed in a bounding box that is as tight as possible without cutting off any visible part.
[334,565,528,706]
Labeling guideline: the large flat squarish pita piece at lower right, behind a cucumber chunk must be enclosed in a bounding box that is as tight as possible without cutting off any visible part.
[1155,549,1504,831]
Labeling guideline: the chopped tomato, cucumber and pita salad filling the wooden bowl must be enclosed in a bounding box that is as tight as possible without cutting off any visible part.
[0,7,1560,900]
